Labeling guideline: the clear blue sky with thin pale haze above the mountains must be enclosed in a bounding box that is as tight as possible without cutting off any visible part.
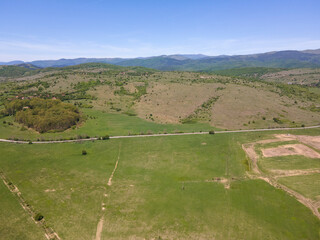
[0,0,320,62]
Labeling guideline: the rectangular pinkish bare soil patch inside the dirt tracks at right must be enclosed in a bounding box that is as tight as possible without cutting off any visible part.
[261,144,320,158]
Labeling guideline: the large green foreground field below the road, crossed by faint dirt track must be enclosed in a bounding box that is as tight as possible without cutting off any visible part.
[0,130,320,239]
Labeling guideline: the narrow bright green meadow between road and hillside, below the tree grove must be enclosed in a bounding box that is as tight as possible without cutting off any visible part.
[0,109,216,140]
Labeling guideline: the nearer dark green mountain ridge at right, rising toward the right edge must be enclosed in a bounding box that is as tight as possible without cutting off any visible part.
[117,51,320,71]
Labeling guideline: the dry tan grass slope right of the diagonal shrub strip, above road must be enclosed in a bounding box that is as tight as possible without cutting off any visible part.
[212,84,320,129]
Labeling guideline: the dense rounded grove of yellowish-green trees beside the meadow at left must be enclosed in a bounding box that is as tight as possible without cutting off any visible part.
[5,98,80,133]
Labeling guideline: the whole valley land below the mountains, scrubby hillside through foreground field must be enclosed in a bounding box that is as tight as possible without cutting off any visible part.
[0,63,320,240]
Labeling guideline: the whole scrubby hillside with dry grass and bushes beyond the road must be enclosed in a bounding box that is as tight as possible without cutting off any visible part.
[0,63,320,134]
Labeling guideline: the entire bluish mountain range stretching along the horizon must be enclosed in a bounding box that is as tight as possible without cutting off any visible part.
[0,49,320,72]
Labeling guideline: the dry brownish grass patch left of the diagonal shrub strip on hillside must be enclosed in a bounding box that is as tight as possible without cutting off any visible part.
[134,83,224,123]
